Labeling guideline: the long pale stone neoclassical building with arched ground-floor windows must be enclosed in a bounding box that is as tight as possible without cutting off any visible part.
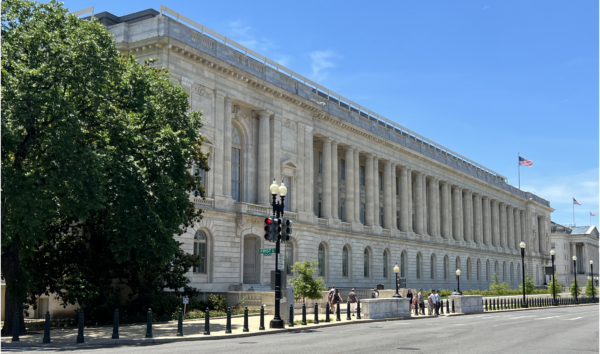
[96,7,553,292]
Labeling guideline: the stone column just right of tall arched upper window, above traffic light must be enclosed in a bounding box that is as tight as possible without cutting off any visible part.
[256,111,273,205]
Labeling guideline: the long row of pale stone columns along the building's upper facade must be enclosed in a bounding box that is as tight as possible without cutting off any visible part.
[321,137,546,252]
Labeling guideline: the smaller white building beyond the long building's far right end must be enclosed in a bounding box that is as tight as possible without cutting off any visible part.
[550,222,600,286]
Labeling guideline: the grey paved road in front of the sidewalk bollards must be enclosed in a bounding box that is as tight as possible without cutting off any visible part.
[3,306,599,354]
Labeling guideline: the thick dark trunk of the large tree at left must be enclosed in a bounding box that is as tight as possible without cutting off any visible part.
[1,246,27,336]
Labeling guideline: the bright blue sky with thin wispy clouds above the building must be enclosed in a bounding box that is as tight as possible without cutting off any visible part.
[65,0,600,225]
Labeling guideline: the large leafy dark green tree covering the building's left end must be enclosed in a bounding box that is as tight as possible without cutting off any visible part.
[1,0,208,334]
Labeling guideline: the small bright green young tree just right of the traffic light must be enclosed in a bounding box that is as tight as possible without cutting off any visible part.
[288,261,327,302]
